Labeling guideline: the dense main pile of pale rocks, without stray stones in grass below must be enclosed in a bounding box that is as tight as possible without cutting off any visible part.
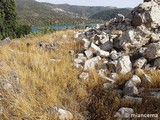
[75,1,160,74]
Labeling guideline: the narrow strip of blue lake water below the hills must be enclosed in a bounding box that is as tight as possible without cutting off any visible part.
[32,24,96,32]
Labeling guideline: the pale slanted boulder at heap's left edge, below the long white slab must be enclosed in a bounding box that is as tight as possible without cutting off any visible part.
[84,56,101,70]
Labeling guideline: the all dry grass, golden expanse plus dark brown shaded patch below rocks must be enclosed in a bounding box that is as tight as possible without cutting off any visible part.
[0,30,159,120]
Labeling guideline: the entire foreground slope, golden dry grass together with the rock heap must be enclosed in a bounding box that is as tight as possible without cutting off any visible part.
[0,1,160,120]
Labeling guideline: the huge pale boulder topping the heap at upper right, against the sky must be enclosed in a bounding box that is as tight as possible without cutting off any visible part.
[132,0,160,28]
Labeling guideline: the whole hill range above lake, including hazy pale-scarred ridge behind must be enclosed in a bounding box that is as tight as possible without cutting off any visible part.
[16,0,115,25]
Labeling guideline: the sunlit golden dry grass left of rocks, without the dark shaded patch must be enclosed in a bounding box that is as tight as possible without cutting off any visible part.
[0,30,102,120]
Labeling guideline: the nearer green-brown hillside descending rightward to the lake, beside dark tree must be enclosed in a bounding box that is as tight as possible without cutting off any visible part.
[16,0,91,25]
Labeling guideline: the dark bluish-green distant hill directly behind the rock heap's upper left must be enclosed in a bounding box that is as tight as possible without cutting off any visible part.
[90,8,132,20]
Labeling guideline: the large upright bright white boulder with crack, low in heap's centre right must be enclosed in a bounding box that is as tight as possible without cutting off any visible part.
[116,56,132,74]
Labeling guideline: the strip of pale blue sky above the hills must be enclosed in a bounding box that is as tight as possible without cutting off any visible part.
[36,0,143,8]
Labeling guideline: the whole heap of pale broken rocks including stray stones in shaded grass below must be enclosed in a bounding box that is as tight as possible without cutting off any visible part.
[74,1,160,118]
